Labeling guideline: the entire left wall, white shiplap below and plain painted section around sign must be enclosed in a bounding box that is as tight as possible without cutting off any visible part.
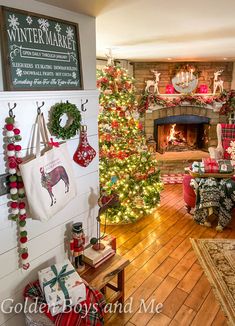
[0,0,99,326]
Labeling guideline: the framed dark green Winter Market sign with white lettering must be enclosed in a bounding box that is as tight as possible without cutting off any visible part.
[0,7,82,91]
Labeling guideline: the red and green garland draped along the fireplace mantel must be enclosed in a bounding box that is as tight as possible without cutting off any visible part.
[138,92,224,114]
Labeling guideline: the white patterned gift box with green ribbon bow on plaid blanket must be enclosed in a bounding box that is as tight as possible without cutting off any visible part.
[38,260,86,316]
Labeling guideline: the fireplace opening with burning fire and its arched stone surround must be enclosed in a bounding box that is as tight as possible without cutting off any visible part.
[145,105,222,153]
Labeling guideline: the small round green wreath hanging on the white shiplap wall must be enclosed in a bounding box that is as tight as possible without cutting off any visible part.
[49,102,81,139]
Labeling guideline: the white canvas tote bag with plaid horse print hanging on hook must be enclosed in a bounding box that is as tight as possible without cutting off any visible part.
[19,114,76,221]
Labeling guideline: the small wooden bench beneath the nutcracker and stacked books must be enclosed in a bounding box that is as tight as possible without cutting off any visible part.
[80,254,130,303]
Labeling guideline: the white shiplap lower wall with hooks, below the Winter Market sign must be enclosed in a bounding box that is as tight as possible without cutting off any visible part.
[0,91,99,325]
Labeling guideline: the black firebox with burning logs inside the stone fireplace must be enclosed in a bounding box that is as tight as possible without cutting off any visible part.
[154,115,210,153]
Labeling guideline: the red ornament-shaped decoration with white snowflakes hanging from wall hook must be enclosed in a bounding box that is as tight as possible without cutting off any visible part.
[73,125,96,167]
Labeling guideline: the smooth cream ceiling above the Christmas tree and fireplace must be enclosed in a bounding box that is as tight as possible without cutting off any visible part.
[35,0,235,61]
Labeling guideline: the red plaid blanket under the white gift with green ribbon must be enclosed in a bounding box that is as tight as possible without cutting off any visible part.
[24,281,106,326]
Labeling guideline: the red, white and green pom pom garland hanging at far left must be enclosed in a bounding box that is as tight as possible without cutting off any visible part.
[5,116,30,270]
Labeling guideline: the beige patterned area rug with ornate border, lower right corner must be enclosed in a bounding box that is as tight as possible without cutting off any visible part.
[191,239,235,325]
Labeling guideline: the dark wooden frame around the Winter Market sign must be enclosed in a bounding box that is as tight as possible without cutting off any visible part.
[0,6,84,91]
